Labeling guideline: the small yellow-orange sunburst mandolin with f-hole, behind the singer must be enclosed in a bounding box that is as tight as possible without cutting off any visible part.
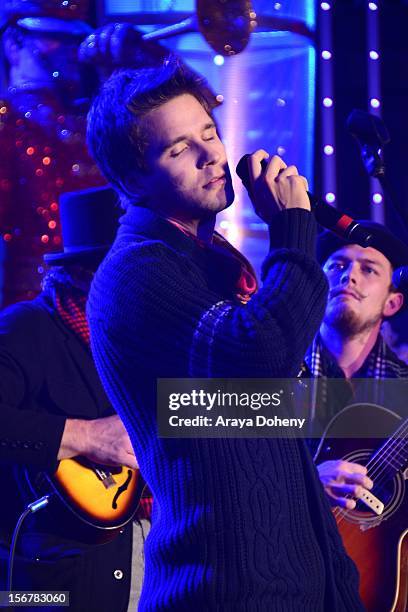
[24,457,150,543]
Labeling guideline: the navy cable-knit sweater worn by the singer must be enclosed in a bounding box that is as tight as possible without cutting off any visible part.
[88,207,362,612]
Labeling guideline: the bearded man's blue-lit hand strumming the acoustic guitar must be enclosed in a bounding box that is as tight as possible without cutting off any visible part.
[317,459,374,510]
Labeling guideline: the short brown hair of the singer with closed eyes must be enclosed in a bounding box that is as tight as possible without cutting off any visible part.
[87,58,218,208]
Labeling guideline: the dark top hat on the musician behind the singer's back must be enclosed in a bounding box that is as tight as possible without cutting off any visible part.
[44,186,121,266]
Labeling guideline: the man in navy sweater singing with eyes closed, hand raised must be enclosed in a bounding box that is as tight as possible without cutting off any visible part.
[88,61,361,612]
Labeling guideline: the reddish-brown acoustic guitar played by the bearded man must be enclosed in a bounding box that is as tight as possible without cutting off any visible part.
[314,404,408,612]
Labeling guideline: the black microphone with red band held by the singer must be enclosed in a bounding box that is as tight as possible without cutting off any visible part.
[237,154,373,247]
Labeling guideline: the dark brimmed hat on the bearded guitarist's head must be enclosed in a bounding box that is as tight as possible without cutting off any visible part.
[316,219,408,269]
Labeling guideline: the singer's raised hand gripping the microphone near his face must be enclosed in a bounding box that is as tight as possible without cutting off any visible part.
[241,149,310,224]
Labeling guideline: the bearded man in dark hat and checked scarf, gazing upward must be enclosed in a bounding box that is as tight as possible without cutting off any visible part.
[303,220,408,509]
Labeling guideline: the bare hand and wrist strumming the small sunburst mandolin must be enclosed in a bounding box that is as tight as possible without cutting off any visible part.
[58,414,138,469]
